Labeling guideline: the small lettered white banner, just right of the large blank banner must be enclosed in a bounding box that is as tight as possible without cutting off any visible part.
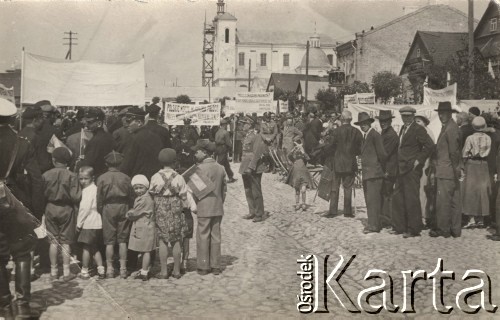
[165,103,220,126]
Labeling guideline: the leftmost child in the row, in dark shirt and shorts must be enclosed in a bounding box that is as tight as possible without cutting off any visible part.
[42,147,81,281]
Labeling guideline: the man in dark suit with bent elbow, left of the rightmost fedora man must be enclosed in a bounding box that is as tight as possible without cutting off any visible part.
[391,106,434,238]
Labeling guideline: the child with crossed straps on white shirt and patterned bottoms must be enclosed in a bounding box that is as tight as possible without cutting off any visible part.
[149,148,188,279]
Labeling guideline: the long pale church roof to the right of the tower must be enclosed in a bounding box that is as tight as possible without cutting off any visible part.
[236,29,335,47]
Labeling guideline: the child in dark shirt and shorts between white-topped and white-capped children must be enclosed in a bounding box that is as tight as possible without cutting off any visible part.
[97,151,134,279]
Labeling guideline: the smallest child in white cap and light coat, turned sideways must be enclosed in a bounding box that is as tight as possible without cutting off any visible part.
[127,175,156,281]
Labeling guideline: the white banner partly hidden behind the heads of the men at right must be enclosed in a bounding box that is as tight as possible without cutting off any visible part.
[346,104,461,142]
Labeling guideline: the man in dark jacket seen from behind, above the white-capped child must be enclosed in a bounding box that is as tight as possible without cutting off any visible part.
[120,107,163,180]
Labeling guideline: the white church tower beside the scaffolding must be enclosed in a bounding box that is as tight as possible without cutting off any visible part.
[213,0,237,86]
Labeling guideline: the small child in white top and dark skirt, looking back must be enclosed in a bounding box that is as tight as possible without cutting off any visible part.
[76,166,106,280]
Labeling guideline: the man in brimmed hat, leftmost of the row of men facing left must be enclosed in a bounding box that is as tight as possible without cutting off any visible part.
[354,112,387,233]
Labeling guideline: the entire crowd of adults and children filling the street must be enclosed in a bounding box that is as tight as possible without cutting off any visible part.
[0,98,500,317]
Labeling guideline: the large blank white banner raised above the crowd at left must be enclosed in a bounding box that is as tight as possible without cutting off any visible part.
[22,53,146,107]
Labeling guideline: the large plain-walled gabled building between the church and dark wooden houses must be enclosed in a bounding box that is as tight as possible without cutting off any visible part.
[337,5,467,83]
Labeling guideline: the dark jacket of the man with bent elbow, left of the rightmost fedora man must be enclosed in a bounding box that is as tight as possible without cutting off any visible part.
[398,122,434,175]
